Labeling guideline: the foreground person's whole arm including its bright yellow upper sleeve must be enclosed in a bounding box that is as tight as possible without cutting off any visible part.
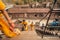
[0,0,14,27]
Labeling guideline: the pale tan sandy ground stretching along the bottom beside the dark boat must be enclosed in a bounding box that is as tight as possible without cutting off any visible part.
[0,31,60,40]
